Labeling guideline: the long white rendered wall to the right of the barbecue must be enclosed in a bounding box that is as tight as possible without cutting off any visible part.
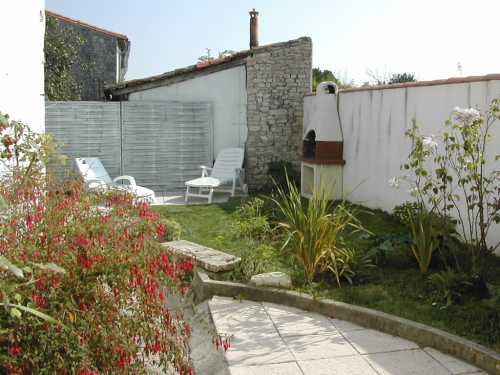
[339,76,500,253]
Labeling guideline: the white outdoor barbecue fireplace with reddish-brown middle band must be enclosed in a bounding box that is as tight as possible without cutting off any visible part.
[301,82,345,199]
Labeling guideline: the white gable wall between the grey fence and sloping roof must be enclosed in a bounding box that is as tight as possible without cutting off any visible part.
[129,66,247,158]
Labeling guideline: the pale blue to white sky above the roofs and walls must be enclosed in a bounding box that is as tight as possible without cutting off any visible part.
[46,0,500,84]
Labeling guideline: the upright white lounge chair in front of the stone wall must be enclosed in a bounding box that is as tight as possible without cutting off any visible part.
[185,148,246,203]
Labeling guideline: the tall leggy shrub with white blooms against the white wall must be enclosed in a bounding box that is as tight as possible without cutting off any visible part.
[396,99,500,272]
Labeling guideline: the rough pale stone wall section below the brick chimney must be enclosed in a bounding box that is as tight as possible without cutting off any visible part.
[246,37,312,190]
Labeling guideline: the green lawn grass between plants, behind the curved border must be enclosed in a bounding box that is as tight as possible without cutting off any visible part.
[152,199,500,351]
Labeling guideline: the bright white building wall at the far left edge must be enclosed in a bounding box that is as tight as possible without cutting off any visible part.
[0,0,45,132]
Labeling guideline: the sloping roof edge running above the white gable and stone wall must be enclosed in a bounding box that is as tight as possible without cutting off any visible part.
[106,37,310,95]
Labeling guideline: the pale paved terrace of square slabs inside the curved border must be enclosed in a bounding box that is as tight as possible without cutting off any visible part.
[209,297,486,375]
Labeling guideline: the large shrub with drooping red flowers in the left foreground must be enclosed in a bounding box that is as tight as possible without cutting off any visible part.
[0,117,194,375]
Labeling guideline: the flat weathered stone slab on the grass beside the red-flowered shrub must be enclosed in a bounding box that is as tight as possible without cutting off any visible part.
[162,240,241,272]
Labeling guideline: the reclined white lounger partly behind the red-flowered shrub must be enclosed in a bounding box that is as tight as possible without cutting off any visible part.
[75,158,155,203]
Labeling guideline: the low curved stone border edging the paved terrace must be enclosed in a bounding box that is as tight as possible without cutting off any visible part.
[193,270,500,375]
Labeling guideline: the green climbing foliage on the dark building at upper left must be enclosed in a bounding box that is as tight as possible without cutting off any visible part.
[45,16,84,100]
